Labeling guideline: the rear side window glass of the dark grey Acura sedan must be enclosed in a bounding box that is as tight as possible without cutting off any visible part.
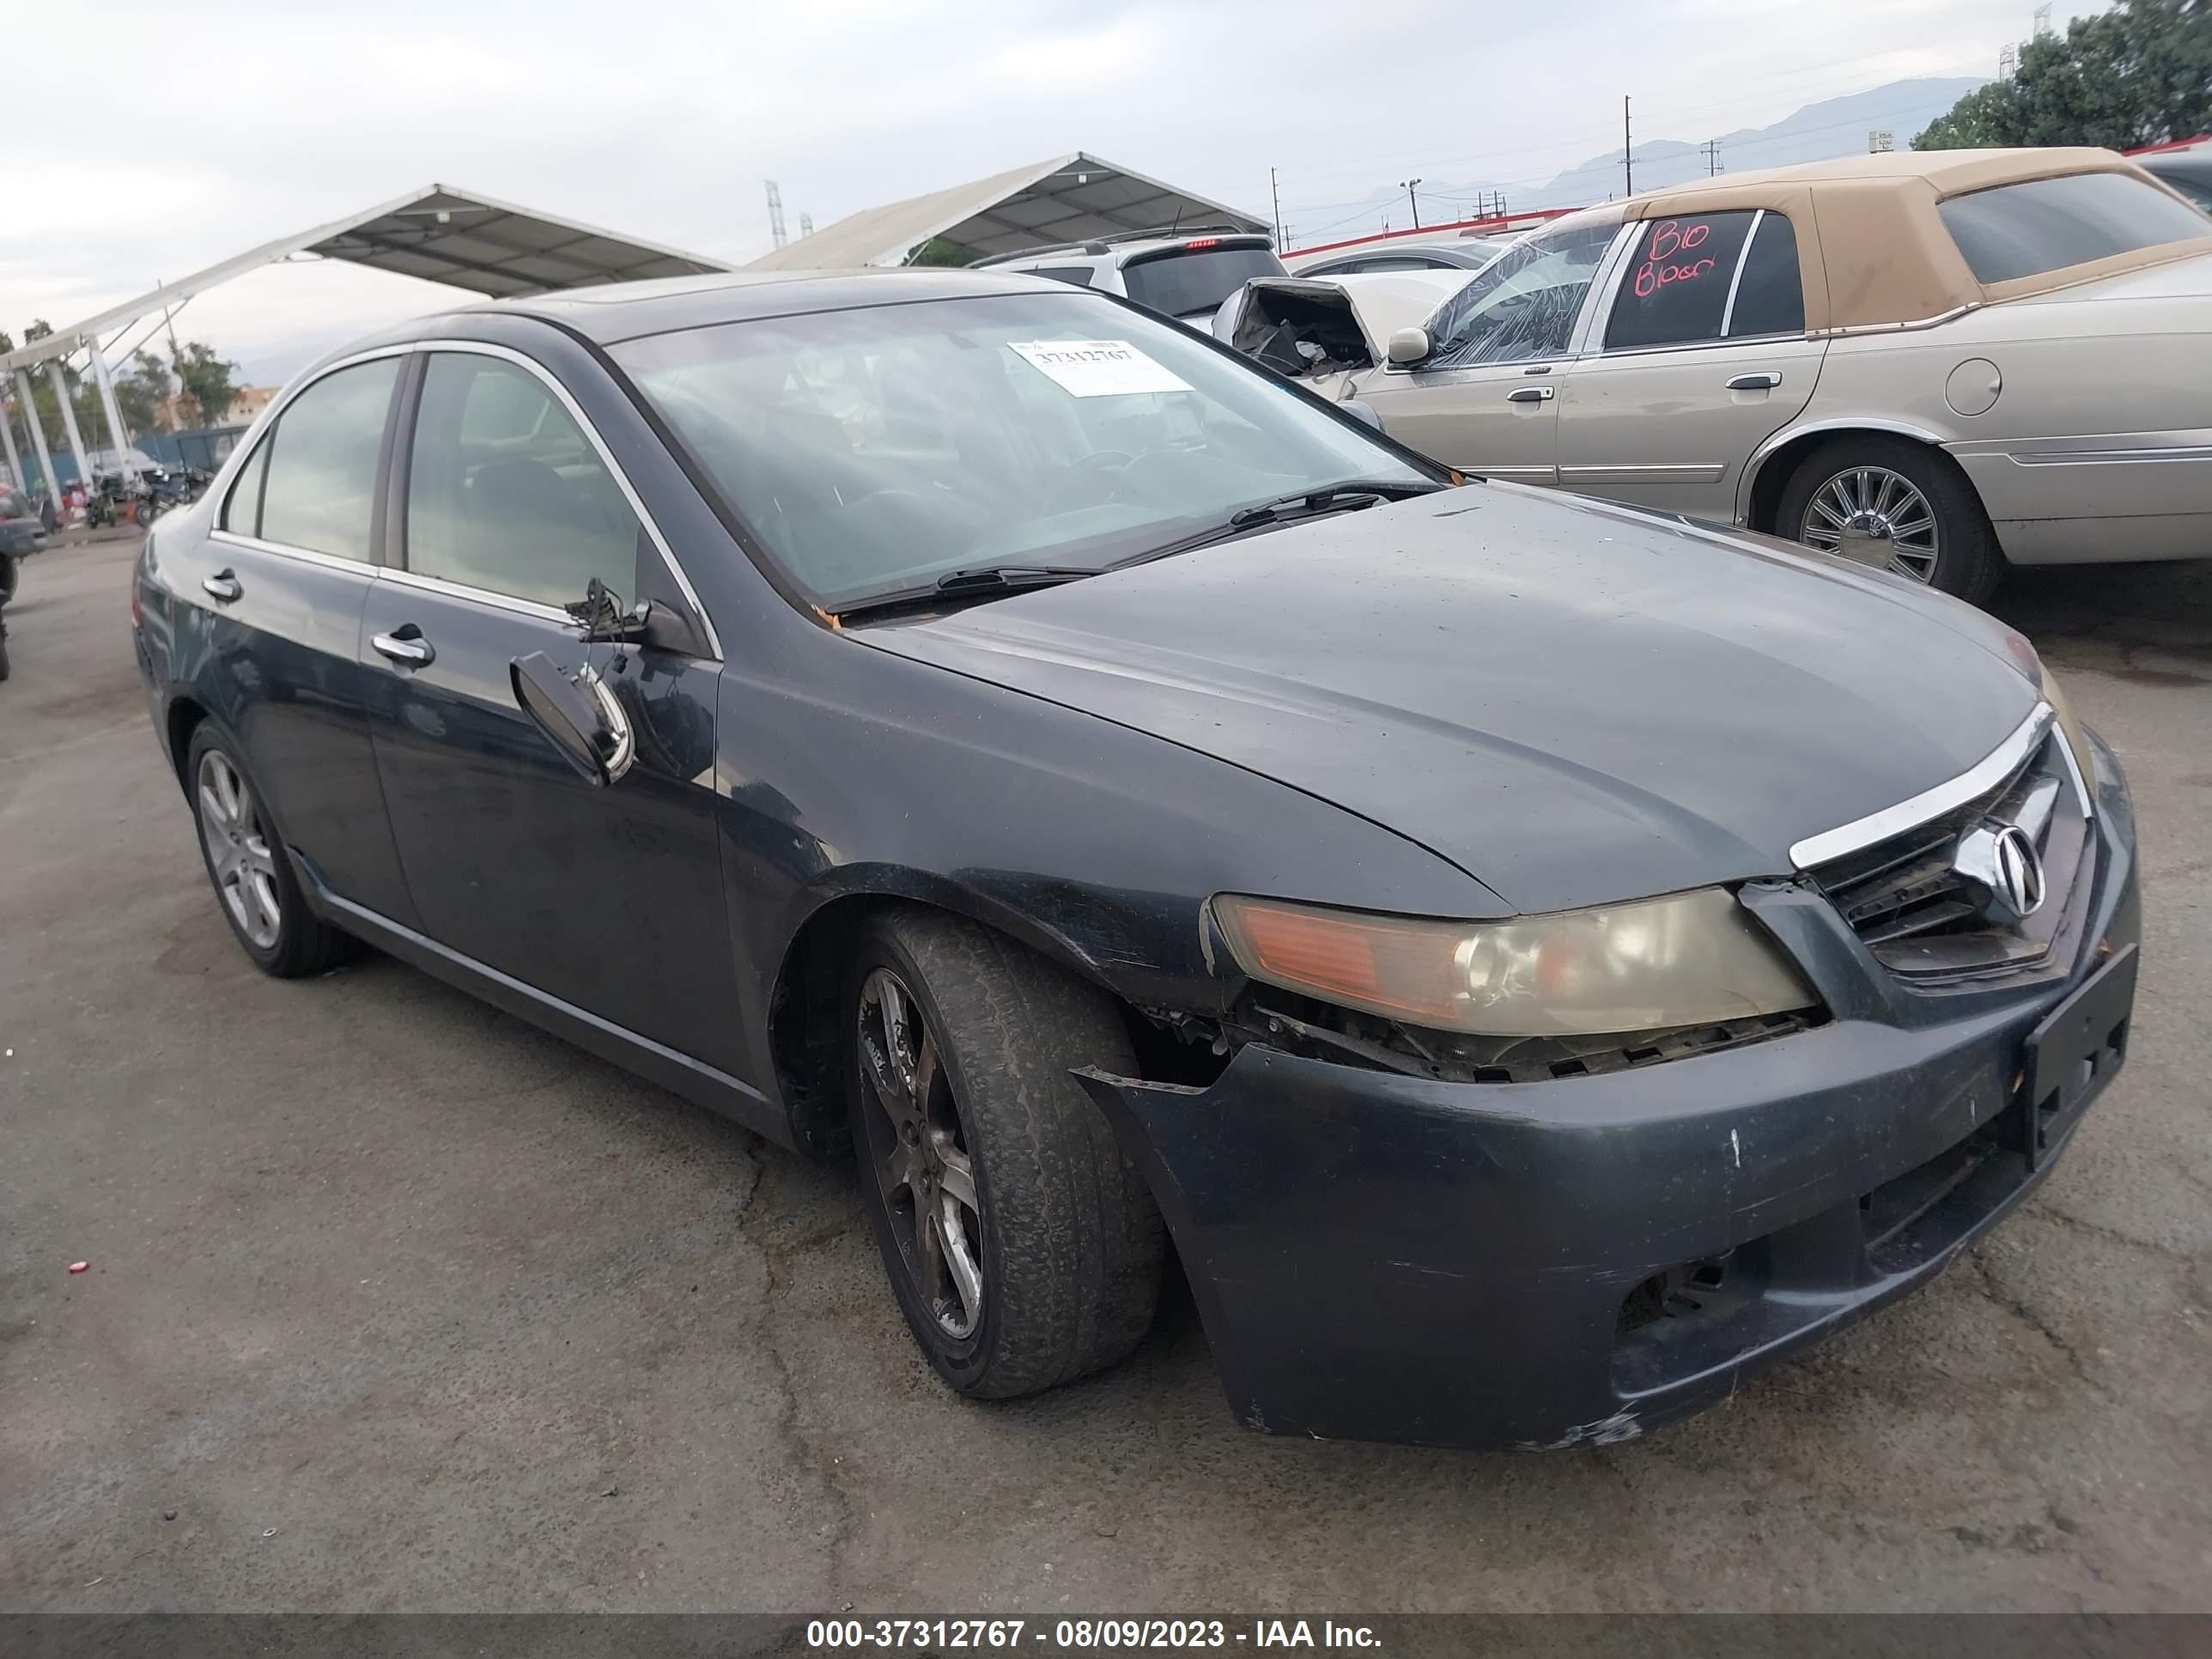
[256,356,400,560]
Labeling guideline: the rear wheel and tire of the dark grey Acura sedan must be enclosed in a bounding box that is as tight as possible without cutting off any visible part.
[184,721,354,980]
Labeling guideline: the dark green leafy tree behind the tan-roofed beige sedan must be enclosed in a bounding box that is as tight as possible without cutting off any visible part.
[1913,0,2212,150]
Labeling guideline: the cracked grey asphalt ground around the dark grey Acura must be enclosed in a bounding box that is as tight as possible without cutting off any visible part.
[0,544,2212,1614]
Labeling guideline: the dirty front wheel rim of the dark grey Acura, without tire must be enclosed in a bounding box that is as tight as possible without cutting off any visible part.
[858,967,982,1340]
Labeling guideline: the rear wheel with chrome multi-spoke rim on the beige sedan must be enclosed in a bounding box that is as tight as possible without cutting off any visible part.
[1774,434,2004,604]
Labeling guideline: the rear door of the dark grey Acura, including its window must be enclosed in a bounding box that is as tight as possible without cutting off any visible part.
[187,352,414,925]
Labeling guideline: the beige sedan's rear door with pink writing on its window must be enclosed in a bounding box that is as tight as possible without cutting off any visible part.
[1559,210,1827,525]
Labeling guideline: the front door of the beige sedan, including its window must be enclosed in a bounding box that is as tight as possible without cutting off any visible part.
[1358,216,1620,484]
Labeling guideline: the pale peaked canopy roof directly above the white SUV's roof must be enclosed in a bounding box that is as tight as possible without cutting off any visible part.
[745,150,1270,270]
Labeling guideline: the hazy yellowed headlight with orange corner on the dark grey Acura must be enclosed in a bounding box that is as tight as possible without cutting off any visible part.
[1214,887,1818,1037]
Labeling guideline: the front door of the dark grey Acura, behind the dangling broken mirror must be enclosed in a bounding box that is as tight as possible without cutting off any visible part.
[361,345,741,1071]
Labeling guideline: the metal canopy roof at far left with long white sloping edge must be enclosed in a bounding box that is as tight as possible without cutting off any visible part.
[0,184,730,374]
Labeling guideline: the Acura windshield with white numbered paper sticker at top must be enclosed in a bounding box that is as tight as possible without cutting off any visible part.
[613,289,1437,611]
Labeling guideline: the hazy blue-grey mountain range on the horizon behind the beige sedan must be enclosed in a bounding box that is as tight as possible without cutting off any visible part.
[1285,76,1984,246]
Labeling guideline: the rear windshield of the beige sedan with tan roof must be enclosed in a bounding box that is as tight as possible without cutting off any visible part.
[1938,173,2212,283]
